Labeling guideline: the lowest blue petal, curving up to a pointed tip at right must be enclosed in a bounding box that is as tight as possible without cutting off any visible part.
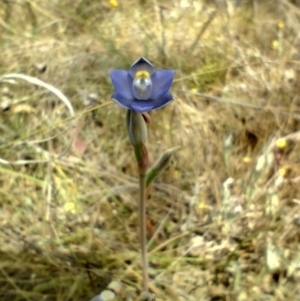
[129,92,173,113]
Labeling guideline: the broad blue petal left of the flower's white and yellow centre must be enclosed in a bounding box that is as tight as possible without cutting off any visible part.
[109,70,133,99]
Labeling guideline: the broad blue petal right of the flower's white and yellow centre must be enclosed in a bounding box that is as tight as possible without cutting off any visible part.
[151,70,175,99]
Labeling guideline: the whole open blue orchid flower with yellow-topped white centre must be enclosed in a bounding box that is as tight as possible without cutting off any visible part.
[110,57,175,113]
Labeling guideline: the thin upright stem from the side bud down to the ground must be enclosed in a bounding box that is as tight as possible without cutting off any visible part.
[139,170,149,291]
